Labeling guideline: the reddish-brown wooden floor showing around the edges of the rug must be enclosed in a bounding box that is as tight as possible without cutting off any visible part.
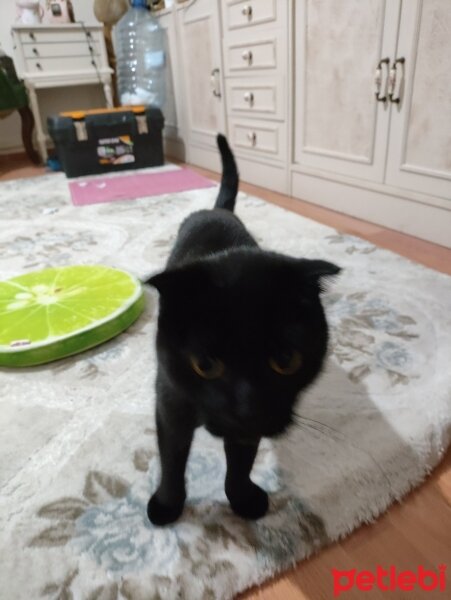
[0,158,451,600]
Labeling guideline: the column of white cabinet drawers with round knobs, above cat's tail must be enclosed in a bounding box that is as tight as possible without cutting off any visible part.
[221,0,289,192]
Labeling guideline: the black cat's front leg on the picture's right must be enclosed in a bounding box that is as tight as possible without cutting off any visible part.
[224,439,268,519]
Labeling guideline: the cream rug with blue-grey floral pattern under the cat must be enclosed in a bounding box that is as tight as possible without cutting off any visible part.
[0,174,451,600]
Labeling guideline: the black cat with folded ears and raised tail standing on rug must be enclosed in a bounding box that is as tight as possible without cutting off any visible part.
[147,135,340,525]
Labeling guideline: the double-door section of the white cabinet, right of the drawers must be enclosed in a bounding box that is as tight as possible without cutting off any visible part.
[290,0,451,246]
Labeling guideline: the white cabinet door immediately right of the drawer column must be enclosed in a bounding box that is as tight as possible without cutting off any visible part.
[294,0,400,181]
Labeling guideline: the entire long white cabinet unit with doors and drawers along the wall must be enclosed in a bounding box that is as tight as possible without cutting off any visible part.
[157,0,451,247]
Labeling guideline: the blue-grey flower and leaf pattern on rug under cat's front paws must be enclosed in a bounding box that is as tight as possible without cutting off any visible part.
[28,428,327,600]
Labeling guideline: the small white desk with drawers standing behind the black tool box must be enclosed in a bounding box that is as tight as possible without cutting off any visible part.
[12,23,113,162]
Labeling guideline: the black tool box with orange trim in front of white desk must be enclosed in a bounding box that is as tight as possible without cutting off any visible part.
[47,106,164,177]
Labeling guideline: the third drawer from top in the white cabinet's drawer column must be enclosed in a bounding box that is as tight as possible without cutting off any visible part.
[226,77,286,119]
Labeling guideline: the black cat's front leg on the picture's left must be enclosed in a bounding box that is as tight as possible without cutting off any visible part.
[147,401,194,525]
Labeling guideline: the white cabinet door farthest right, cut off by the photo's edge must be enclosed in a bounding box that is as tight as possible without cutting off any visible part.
[387,0,451,202]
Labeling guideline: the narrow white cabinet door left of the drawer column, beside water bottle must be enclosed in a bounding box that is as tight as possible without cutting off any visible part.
[177,0,225,159]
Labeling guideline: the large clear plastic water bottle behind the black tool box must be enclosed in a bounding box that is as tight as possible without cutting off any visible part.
[114,0,166,108]
